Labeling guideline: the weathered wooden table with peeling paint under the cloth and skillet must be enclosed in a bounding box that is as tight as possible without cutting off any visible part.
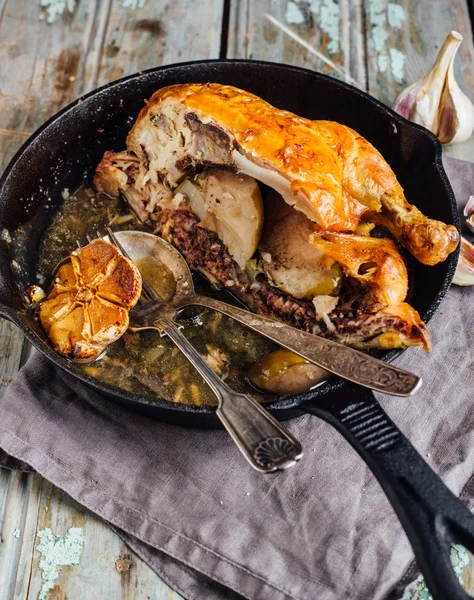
[0,0,474,600]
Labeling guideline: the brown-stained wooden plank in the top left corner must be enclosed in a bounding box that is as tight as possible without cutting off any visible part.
[0,0,107,133]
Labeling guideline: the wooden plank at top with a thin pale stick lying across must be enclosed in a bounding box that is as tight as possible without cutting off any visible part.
[228,0,365,87]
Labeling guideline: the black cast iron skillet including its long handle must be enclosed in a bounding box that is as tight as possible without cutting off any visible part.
[0,60,474,600]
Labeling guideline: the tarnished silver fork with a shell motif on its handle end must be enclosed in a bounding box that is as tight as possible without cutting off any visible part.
[107,229,303,473]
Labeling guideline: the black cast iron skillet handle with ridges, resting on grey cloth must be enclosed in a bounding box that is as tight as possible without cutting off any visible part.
[301,386,474,600]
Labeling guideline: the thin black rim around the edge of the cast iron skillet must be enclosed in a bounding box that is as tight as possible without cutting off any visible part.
[0,58,461,415]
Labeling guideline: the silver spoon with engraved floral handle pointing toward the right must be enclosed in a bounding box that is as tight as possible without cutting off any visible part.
[109,231,422,396]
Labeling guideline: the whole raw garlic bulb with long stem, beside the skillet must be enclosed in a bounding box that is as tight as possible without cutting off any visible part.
[393,31,474,144]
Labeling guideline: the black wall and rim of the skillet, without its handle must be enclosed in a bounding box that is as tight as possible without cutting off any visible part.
[0,60,459,426]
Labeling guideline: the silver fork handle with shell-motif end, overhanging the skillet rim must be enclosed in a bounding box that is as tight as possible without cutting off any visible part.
[155,317,303,473]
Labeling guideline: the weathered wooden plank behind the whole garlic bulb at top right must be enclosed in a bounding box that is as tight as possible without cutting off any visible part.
[365,0,474,160]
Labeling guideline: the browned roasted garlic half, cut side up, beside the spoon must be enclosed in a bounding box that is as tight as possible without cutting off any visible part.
[39,239,142,360]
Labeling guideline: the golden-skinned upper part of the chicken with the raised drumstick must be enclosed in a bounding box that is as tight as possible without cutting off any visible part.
[127,83,459,265]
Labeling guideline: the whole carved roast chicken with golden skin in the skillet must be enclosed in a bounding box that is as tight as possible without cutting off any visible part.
[94,84,459,348]
